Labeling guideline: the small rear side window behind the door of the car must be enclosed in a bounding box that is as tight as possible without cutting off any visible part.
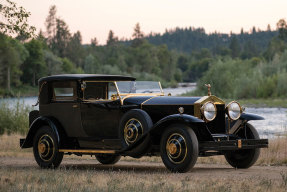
[53,82,77,101]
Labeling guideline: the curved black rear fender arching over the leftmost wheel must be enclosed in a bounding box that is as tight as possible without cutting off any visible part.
[20,116,63,148]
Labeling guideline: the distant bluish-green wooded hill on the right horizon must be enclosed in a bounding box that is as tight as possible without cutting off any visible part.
[146,25,278,54]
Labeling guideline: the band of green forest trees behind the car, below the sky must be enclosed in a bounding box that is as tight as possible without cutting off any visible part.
[0,3,287,98]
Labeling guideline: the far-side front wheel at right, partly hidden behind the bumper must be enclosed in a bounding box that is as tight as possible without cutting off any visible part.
[224,123,260,169]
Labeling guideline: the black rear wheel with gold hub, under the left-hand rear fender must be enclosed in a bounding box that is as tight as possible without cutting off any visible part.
[33,126,64,168]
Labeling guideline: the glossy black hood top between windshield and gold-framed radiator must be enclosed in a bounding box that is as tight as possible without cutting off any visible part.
[124,96,201,105]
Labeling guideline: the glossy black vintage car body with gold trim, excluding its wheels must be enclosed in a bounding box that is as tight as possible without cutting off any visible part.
[21,74,268,157]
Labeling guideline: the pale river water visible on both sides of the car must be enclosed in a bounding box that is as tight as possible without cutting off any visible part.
[0,93,287,138]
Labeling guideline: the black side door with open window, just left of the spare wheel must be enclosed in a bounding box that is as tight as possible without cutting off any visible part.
[81,82,120,139]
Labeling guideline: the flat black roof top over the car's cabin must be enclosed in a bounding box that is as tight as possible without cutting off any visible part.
[39,74,136,84]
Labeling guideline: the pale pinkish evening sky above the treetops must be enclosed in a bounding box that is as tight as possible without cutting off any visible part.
[18,0,287,44]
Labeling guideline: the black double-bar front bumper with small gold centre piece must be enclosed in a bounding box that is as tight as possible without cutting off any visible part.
[199,139,268,151]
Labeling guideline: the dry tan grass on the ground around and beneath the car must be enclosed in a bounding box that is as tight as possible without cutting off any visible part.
[0,135,287,192]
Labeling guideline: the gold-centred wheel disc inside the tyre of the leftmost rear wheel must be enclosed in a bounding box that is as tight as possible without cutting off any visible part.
[38,134,55,161]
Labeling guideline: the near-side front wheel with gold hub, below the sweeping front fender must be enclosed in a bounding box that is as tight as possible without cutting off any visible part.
[160,124,198,173]
